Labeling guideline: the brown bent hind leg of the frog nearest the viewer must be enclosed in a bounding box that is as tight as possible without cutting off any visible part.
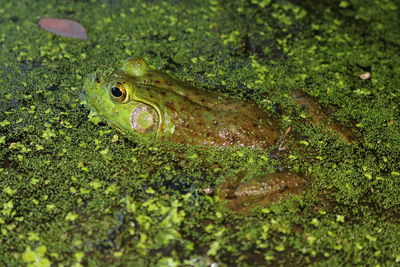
[220,171,307,212]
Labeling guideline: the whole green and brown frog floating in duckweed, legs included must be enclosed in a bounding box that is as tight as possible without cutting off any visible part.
[84,57,355,214]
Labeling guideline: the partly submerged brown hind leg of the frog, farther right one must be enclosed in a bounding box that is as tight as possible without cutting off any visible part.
[292,91,359,144]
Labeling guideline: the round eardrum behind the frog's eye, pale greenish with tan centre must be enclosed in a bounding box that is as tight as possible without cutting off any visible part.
[130,102,160,133]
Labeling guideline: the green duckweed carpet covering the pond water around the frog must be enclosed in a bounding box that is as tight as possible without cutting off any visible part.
[0,0,400,266]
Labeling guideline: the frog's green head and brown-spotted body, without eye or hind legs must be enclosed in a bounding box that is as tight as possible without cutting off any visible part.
[86,58,280,148]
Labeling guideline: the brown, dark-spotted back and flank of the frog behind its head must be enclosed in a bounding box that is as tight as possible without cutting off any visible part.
[152,86,280,148]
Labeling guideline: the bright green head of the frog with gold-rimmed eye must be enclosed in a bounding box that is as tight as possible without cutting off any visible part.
[84,58,161,137]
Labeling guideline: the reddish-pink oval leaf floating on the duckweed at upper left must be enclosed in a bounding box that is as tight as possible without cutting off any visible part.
[37,18,87,40]
